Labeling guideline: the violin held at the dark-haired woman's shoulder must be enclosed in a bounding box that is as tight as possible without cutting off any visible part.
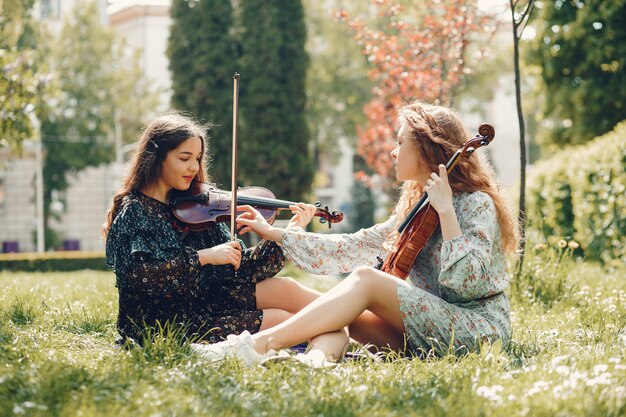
[169,180,343,231]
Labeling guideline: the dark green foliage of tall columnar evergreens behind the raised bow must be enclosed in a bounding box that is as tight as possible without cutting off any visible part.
[168,0,313,200]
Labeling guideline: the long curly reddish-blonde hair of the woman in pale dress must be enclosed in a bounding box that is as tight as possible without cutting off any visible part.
[385,102,519,253]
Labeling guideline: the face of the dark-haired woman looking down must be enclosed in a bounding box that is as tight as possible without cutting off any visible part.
[159,137,202,190]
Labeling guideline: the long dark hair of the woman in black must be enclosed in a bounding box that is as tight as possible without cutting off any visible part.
[102,112,210,239]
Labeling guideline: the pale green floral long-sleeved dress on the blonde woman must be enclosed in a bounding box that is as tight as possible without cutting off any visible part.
[282,192,511,355]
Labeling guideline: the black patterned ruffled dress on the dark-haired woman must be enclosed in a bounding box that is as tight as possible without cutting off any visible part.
[106,193,285,343]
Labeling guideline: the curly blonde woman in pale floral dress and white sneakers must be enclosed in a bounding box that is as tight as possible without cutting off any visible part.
[196,103,517,362]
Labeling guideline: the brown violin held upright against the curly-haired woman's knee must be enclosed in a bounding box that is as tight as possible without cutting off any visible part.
[378,123,496,279]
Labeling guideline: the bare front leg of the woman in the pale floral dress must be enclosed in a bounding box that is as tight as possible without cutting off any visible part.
[253,268,404,352]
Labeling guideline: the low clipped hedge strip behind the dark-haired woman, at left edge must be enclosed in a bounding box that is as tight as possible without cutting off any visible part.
[0,251,107,272]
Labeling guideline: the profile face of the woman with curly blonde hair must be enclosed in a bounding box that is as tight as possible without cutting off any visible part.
[390,123,430,185]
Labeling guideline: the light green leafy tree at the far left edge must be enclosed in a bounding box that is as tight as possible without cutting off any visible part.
[0,0,50,153]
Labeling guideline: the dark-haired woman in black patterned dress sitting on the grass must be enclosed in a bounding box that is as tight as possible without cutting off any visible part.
[102,114,326,343]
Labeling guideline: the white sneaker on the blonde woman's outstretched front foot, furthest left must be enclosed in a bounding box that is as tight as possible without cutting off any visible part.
[191,330,274,366]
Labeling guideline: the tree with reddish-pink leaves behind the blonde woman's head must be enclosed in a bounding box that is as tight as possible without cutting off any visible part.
[337,0,496,180]
